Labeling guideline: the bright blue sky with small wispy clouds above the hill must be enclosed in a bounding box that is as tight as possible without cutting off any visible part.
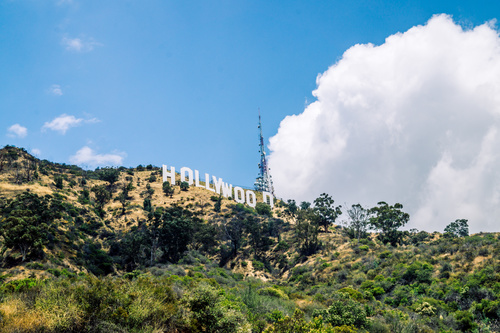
[0,0,500,202]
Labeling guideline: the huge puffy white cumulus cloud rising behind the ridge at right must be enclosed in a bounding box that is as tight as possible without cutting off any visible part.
[269,15,500,232]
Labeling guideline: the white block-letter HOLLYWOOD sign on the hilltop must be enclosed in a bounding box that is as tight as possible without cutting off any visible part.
[162,164,274,208]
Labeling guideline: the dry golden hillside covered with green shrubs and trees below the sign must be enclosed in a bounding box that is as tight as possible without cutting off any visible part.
[0,146,500,332]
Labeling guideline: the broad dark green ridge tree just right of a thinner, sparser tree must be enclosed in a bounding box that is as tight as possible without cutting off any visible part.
[369,201,410,246]
